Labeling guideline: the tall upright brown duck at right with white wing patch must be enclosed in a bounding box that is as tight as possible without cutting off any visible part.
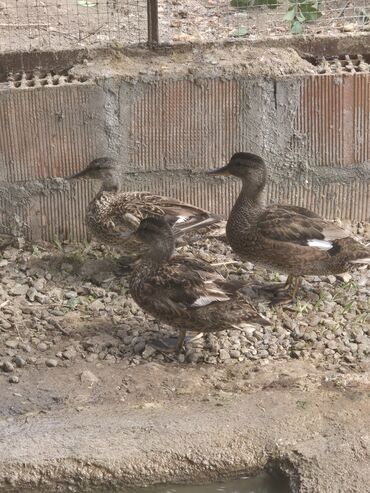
[208,152,370,303]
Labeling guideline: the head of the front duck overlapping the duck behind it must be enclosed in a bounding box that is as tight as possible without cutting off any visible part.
[134,217,175,261]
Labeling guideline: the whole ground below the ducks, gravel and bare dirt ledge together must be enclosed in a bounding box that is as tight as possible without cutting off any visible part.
[0,224,370,493]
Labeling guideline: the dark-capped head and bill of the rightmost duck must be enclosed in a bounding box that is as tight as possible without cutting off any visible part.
[208,152,267,191]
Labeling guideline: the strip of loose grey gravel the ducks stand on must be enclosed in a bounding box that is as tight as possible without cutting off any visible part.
[0,219,370,383]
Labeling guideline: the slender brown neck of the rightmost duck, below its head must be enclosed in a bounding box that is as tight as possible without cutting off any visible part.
[227,180,264,235]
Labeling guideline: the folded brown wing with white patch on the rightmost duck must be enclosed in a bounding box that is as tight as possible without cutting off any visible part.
[257,206,349,250]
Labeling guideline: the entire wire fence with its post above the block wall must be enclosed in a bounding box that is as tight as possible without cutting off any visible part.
[0,0,370,51]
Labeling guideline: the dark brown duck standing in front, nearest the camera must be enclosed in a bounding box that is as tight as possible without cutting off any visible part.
[129,216,270,352]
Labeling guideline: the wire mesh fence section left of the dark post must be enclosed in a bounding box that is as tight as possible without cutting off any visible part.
[0,0,147,51]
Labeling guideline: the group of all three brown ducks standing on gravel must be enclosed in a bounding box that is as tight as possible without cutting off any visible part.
[68,152,370,352]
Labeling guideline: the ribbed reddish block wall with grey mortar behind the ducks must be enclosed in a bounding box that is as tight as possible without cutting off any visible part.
[0,45,370,241]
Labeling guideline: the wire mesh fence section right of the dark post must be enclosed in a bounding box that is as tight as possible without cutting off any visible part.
[159,0,370,42]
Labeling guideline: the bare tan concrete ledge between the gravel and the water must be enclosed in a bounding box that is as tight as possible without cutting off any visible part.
[0,361,370,493]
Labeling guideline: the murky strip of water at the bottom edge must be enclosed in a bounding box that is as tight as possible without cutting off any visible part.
[100,474,291,493]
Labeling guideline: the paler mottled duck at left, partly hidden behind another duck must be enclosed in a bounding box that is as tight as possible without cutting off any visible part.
[66,157,221,263]
